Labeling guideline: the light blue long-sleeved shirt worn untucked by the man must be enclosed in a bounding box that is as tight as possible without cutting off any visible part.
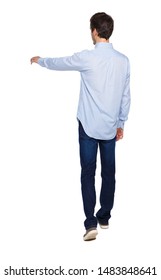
[38,42,130,140]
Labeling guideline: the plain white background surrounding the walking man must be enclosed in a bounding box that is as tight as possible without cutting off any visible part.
[0,0,161,280]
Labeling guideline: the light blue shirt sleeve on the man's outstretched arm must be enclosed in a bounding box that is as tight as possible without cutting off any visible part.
[38,51,88,72]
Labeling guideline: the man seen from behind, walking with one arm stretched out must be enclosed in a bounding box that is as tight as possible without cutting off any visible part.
[31,13,130,241]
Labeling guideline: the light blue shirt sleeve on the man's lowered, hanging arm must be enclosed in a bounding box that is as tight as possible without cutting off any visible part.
[117,61,131,129]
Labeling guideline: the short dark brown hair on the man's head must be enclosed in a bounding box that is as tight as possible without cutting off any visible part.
[90,13,114,40]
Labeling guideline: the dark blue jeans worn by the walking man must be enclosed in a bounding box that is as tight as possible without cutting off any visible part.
[79,122,116,229]
